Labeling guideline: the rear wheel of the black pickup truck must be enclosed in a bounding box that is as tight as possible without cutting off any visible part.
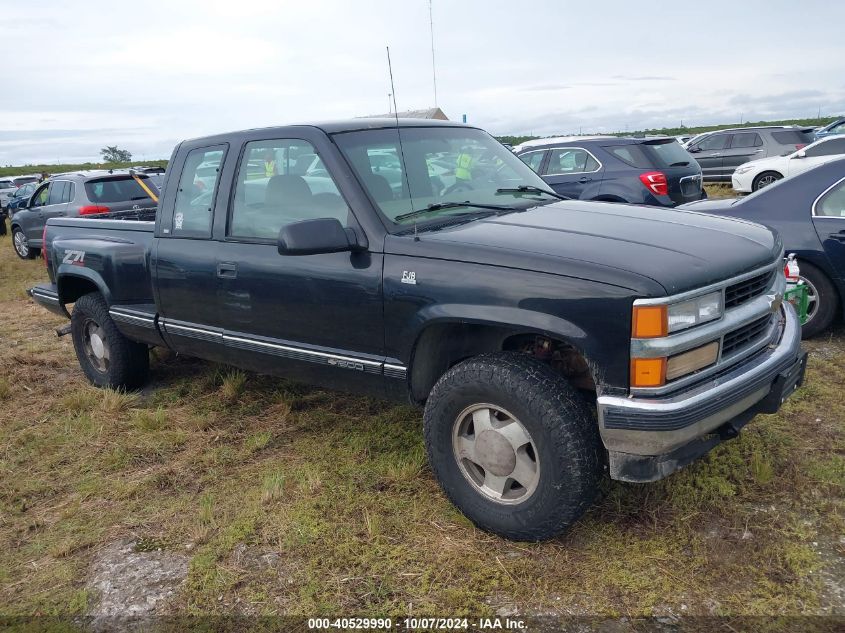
[70,292,150,389]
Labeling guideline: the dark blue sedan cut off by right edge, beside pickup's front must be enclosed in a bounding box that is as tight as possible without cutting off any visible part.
[682,159,845,337]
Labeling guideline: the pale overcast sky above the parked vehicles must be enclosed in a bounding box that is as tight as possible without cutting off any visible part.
[0,0,845,165]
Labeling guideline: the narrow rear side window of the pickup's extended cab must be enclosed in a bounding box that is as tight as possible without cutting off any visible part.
[171,145,225,237]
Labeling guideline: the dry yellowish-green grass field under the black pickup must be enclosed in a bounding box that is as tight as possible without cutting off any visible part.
[0,227,845,615]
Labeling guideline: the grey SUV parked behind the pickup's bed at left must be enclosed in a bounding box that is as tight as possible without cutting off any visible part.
[11,170,161,259]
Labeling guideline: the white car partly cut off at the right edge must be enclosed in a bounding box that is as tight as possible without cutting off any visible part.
[731,136,845,193]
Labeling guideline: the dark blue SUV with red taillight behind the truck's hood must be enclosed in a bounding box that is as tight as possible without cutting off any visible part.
[515,136,705,207]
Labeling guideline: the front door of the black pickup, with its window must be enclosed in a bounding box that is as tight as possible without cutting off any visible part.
[216,138,390,393]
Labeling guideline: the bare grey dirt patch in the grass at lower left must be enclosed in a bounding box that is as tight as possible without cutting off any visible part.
[87,539,188,623]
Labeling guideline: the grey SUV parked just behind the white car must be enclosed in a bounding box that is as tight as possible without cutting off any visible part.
[687,126,814,181]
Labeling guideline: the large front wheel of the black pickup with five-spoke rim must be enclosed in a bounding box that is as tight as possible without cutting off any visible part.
[424,353,604,541]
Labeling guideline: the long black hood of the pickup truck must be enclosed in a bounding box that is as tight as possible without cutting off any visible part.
[385,201,782,296]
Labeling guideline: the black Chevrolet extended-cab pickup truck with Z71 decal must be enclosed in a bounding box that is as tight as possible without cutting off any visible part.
[30,119,806,540]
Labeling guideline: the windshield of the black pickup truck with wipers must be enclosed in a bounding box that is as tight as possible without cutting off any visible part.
[334,127,556,225]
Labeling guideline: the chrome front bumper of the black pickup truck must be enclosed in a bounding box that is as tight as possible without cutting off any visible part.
[598,303,807,482]
